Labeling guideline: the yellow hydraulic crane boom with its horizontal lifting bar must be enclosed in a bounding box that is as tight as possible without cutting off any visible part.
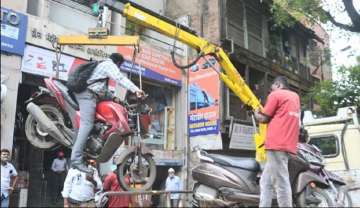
[58,0,267,162]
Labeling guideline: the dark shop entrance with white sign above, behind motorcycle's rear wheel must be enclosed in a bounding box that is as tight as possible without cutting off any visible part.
[15,44,90,207]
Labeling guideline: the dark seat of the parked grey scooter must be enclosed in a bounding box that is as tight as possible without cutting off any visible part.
[207,154,260,171]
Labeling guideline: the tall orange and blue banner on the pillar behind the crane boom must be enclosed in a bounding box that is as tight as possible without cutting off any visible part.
[188,56,220,137]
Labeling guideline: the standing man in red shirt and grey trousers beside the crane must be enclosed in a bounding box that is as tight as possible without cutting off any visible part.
[254,76,300,207]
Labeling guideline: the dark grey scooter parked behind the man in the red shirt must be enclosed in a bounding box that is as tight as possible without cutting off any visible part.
[192,144,335,207]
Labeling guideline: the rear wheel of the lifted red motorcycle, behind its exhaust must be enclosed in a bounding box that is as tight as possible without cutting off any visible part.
[25,104,64,149]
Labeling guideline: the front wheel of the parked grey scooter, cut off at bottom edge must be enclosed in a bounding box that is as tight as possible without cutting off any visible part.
[297,186,335,207]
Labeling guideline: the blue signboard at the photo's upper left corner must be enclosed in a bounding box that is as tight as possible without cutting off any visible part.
[1,7,28,56]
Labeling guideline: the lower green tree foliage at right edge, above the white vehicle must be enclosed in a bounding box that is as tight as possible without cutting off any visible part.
[304,57,360,116]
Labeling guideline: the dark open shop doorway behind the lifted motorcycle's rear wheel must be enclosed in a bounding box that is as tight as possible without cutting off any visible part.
[14,77,71,207]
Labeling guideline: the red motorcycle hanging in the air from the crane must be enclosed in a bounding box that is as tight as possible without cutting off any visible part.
[25,78,156,190]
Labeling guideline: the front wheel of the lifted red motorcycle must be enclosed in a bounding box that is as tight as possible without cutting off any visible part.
[117,152,156,191]
